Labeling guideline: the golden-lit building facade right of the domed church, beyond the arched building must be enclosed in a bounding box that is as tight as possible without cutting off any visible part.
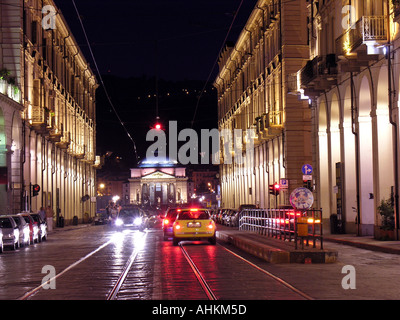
[214,0,312,208]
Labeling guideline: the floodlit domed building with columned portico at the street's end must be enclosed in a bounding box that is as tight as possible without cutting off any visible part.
[129,157,188,206]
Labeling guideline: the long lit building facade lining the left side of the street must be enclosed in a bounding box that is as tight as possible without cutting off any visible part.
[0,0,99,223]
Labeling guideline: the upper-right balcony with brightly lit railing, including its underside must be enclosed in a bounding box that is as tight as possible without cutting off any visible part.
[336,16,387,72]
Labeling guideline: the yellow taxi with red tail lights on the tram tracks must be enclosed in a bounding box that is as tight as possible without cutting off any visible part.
[172,208,217,246]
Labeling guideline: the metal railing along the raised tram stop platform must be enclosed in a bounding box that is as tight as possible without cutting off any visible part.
[239,209,323,250]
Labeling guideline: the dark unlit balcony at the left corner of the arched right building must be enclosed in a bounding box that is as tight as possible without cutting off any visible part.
[298,54,338,96]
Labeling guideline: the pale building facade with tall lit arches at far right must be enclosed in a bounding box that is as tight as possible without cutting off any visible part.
[293,0,400,238]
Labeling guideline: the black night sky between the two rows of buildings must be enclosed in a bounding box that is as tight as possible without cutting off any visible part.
[55,0,257,168]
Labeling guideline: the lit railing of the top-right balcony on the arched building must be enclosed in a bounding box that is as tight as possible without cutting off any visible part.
[336,16,387,56]
